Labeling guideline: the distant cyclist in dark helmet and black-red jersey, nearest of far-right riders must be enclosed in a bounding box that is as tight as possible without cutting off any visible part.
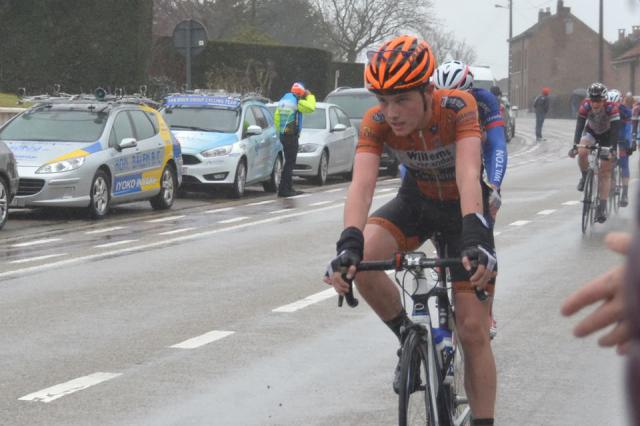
[569,83,620,223]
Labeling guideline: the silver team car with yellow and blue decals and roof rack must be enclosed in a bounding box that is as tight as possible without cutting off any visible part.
[0,96,182,219]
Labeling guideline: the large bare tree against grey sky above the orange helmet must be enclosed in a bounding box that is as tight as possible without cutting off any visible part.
[313,0,432,62]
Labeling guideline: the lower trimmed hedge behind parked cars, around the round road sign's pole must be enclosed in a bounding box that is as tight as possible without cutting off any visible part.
[150,37,333,100]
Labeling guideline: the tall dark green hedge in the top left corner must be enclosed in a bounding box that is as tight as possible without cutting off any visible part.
[0,0,153,94]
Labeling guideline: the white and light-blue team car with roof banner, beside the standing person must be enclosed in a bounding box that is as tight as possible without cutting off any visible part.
[162,93,284,198]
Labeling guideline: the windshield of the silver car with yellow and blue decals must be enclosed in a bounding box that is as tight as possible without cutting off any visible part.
[0,109,108,142]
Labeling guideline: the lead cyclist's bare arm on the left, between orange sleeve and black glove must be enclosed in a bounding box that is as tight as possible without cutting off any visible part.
[344,152,380,231]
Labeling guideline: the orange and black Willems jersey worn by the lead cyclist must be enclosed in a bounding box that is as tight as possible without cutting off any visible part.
[356,89,481,201]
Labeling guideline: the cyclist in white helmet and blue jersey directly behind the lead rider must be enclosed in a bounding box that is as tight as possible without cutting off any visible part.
[433,61,507,338]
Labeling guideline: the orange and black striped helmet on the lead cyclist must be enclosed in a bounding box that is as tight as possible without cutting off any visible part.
[364,35,436,94]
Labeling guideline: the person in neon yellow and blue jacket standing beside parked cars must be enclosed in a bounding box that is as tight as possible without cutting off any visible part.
[274,82,316,197]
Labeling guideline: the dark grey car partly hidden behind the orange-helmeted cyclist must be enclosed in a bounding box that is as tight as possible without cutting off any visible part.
[324,87,399,176]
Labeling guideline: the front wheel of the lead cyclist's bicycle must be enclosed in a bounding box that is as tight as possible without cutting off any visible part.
[398,331,440,426]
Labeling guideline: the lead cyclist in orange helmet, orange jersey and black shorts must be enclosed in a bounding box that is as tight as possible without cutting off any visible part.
[325,36,497,425]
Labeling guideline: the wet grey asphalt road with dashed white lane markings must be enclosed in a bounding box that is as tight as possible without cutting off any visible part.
[0,119,637,425]
